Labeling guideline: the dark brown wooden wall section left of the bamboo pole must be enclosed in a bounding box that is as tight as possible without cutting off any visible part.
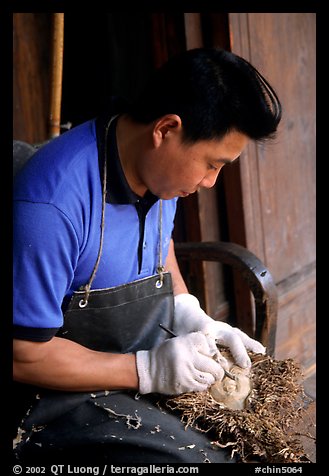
[13,13,52,143]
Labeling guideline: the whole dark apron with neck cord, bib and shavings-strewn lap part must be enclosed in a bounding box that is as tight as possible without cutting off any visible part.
[14,116,231,464]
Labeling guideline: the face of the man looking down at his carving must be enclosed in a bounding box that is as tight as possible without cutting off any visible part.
[143,124,249,200]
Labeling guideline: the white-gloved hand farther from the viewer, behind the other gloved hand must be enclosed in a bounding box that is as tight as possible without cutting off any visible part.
[173,293,266,368]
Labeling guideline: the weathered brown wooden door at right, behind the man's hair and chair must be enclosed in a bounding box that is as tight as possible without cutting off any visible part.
[226,13,316,372]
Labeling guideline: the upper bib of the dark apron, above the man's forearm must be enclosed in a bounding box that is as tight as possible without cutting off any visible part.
[57,273,174,353]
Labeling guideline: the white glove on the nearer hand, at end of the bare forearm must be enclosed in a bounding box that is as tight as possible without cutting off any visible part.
[136,332,224,395]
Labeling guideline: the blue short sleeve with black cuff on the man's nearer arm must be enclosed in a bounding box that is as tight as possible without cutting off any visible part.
[13,200,79,341]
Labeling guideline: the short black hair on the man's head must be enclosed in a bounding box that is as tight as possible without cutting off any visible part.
[129,48,282,143]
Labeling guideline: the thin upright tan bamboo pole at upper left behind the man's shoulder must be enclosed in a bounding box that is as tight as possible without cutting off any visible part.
[49,13,64,138]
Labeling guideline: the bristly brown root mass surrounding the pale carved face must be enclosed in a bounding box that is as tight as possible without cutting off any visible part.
[165,353,309,463]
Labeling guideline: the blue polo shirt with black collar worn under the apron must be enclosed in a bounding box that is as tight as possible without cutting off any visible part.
[13,113,177,341]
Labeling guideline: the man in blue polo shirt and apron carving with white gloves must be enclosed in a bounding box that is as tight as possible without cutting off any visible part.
[14,49,281,463]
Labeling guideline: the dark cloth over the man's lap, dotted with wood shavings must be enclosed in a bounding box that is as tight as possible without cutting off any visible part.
[14,392,237,465]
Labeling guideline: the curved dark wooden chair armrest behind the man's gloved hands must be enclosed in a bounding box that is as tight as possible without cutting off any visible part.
[175,241,278,356]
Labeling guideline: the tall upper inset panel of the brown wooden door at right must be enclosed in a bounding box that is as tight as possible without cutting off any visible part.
[249,13,315,281]
